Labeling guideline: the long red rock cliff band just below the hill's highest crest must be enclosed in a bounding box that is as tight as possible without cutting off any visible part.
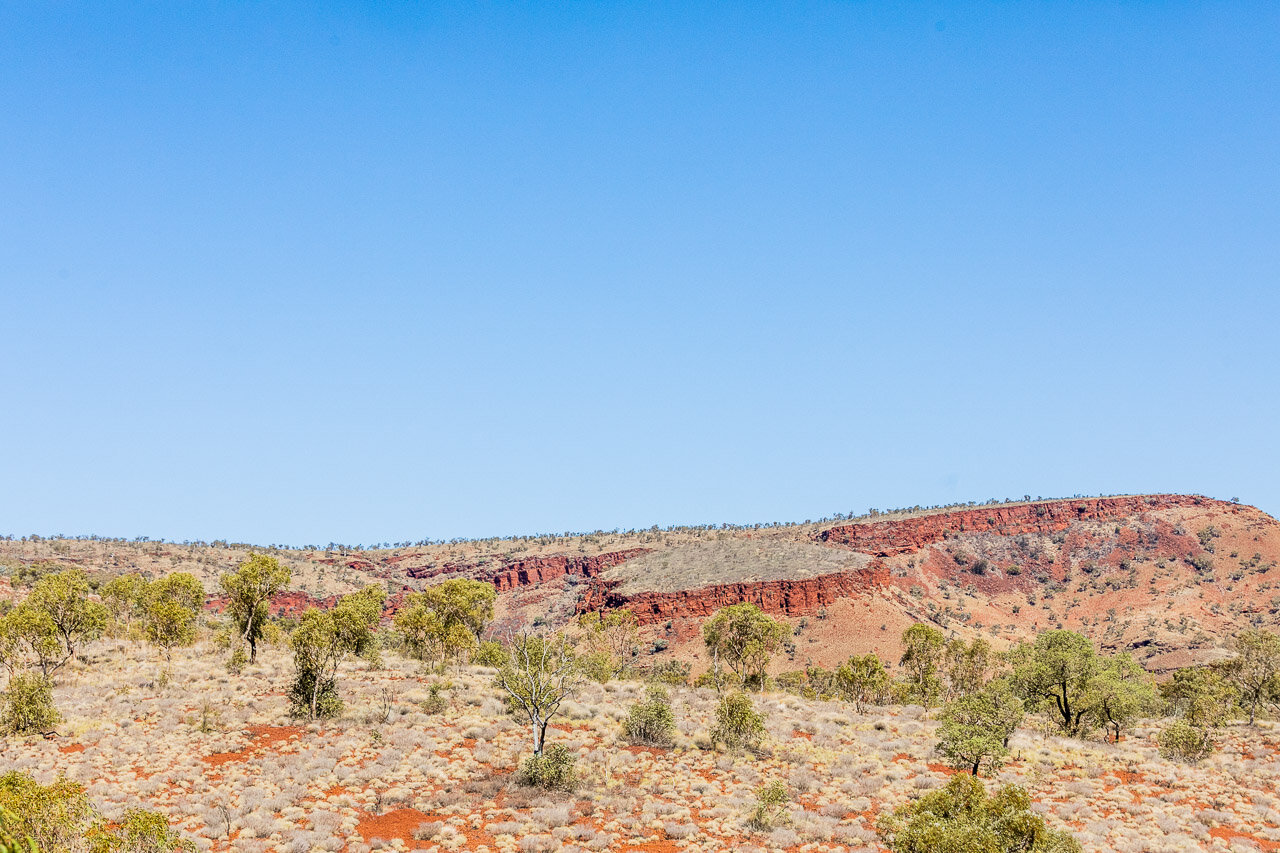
[818,494,1213,557]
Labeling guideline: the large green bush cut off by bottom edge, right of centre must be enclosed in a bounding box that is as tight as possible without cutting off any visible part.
[879,774,1082,853]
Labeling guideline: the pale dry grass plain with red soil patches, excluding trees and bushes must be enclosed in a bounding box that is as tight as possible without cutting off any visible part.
[4,627,1280,853]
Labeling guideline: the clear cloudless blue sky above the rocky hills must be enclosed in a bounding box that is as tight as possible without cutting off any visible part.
[0,3,1280,544]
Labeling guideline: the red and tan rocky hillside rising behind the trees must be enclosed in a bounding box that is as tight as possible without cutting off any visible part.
[0,494,1280,671]
